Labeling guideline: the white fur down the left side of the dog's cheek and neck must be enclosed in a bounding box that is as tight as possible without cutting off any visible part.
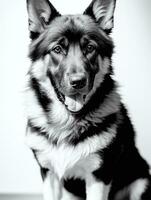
[25,56,73,141]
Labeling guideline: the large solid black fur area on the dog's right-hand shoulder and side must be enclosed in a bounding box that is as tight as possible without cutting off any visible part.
[93,105,150,200]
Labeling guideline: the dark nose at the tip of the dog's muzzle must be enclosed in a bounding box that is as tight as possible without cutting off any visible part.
[70,75,86,89]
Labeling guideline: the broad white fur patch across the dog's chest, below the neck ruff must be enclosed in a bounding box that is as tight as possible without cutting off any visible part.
[27,127,115,179]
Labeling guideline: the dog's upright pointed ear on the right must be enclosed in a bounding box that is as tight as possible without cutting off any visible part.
[84,0,116,33]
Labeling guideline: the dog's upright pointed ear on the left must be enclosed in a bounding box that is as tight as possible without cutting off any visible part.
[27,0,60,39]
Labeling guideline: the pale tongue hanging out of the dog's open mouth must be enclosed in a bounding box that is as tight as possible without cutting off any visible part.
[65,95,84,112]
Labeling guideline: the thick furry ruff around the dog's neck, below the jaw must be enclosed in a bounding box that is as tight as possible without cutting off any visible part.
[26,59,120,143]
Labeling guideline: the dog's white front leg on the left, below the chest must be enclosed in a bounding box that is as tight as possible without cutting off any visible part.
[43,171,62,200]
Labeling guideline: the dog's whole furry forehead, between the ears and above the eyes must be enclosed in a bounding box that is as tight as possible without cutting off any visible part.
[30,15,113,60]
